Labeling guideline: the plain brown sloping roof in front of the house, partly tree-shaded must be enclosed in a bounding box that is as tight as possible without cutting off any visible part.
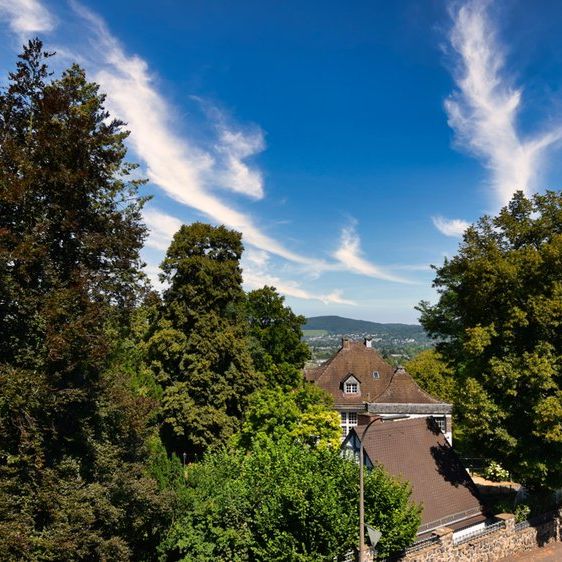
[354,418,483,532]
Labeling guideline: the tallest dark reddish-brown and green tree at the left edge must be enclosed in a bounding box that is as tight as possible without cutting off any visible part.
[0,40,166,560]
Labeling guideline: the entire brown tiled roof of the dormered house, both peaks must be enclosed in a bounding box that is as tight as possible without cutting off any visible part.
[305,341,440,406]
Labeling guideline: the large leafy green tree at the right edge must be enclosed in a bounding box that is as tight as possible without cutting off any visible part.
[420,191,562,488]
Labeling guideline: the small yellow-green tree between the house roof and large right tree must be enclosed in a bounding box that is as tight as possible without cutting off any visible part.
[404,349,455,404]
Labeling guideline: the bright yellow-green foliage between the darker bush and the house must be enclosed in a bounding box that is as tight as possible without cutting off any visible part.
[235,383,341,449]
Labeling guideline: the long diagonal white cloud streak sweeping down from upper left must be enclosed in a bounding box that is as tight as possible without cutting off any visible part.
[72,2,323,266]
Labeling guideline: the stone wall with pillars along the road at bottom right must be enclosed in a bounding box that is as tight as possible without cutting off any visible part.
[382,510,562,562]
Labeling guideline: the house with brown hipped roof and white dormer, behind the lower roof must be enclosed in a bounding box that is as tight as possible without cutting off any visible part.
[305,338,452,443]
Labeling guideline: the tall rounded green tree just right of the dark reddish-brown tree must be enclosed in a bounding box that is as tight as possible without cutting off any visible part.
[146,223,262,460]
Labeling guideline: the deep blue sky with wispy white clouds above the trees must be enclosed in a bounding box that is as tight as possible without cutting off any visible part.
[0,0,562,322]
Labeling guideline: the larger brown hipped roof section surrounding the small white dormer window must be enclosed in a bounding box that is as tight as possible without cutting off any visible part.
[305,342,394,404]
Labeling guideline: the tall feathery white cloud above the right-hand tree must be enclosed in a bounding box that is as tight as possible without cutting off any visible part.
[445,0,562,205]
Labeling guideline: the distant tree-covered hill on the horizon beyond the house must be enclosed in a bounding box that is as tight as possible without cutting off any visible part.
[303,316,428,340]
